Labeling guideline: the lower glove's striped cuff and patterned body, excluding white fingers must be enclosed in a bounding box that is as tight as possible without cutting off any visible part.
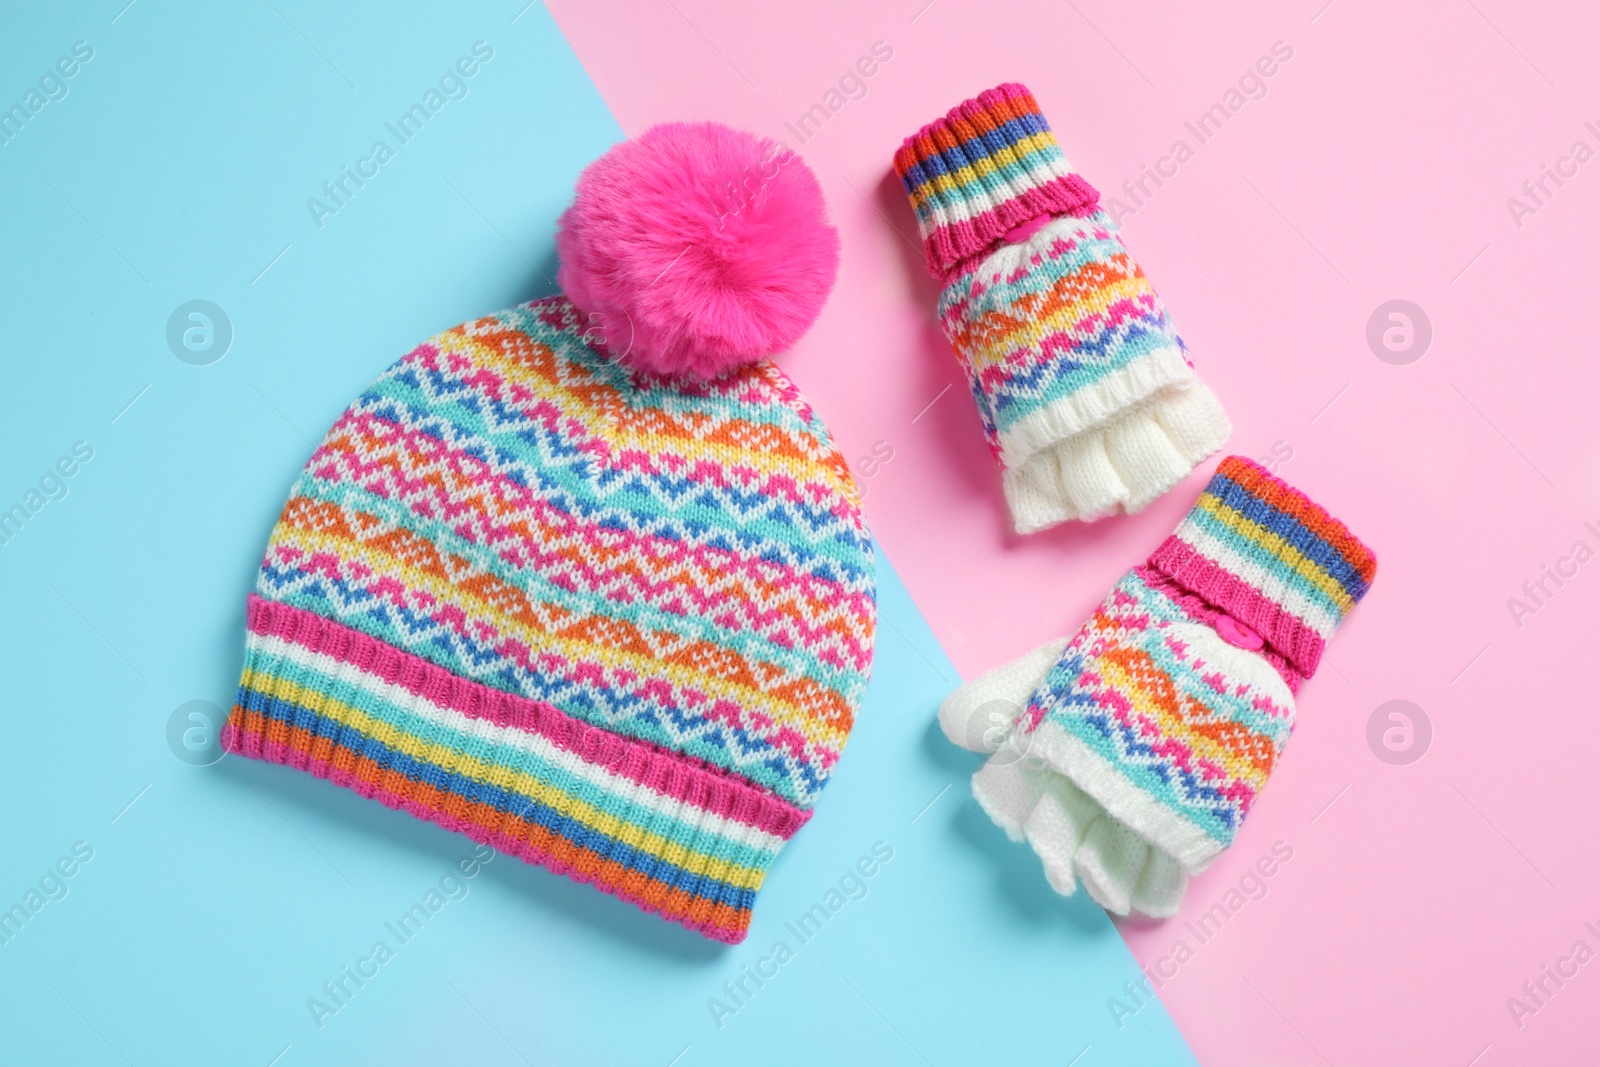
[1021,456,1376,872]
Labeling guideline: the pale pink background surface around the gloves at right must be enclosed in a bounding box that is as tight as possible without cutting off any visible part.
[550,0,1600,1067]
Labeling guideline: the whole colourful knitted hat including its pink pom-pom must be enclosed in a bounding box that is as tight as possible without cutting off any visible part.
[224,125,875,942]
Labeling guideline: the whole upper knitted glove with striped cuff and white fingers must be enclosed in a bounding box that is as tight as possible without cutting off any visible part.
[894,85,1230,533]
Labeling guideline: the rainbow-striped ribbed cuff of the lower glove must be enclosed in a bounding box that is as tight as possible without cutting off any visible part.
[1150,456,1378,678]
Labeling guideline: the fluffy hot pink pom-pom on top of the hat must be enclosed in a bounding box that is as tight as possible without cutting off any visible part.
[555,122,838,379]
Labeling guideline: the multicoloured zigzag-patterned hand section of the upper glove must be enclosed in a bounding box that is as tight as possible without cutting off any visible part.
[939,211,1187,461]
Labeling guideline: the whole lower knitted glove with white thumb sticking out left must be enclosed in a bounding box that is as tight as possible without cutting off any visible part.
[939,456,1378,917]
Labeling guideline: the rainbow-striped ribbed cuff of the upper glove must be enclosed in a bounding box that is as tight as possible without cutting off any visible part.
[894,83,1099,280]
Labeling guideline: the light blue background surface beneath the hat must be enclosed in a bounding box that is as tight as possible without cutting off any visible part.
[0,0,1192,1067]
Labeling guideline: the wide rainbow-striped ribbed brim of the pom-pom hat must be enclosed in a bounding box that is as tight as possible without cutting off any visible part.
[222,595,810,944]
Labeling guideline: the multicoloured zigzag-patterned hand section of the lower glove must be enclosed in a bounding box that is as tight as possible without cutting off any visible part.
[1021,568,1294,859]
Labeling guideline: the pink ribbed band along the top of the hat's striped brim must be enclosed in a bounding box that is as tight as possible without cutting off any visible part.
[246,593,811,840]
